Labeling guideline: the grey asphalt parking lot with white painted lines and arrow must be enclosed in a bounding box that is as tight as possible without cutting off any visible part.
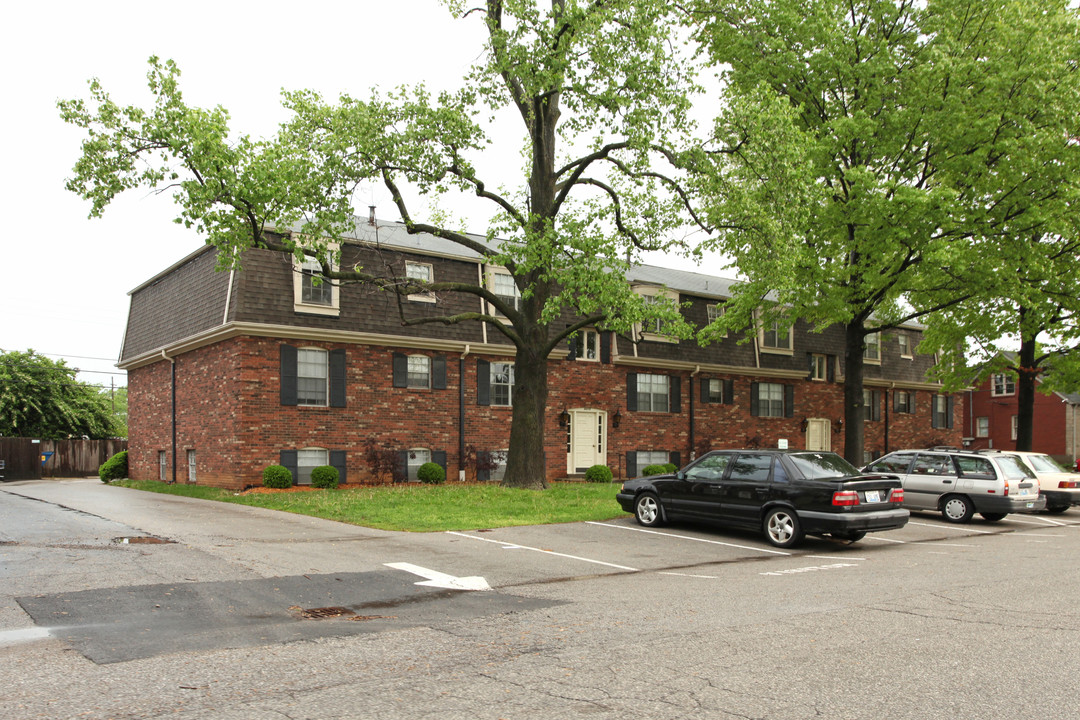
[6,481,1080,720]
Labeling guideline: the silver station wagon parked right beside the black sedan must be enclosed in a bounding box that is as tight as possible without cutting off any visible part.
[864,449,1047,522]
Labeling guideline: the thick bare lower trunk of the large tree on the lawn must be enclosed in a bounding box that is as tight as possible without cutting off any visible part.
[502,326,548,490]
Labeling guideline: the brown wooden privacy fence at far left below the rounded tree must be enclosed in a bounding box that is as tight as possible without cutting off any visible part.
[0,437,127,480]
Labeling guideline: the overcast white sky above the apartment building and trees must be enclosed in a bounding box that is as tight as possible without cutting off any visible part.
[0,0,717,386]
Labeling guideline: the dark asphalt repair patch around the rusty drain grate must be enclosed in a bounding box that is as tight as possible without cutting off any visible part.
[16,571,562,665]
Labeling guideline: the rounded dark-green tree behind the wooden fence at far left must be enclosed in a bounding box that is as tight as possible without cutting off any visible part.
[0,350,112,439]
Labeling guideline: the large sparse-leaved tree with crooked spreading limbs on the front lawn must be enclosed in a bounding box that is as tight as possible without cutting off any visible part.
[59,0,696,488]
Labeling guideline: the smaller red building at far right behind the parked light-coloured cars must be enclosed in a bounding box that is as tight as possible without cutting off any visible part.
[963,372,1080,467]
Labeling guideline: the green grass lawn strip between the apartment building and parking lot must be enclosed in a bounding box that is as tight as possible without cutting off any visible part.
[112,480,625,532]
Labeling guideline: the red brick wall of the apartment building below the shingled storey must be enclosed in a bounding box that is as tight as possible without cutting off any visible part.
[129,338,962,488]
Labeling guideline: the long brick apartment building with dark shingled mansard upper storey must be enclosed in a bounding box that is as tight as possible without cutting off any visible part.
[120,222,962,488]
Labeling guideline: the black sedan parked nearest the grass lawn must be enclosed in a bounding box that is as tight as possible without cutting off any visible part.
[616,450,908,547]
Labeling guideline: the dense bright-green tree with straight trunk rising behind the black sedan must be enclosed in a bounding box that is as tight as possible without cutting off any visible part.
[692,0,1080,462]
